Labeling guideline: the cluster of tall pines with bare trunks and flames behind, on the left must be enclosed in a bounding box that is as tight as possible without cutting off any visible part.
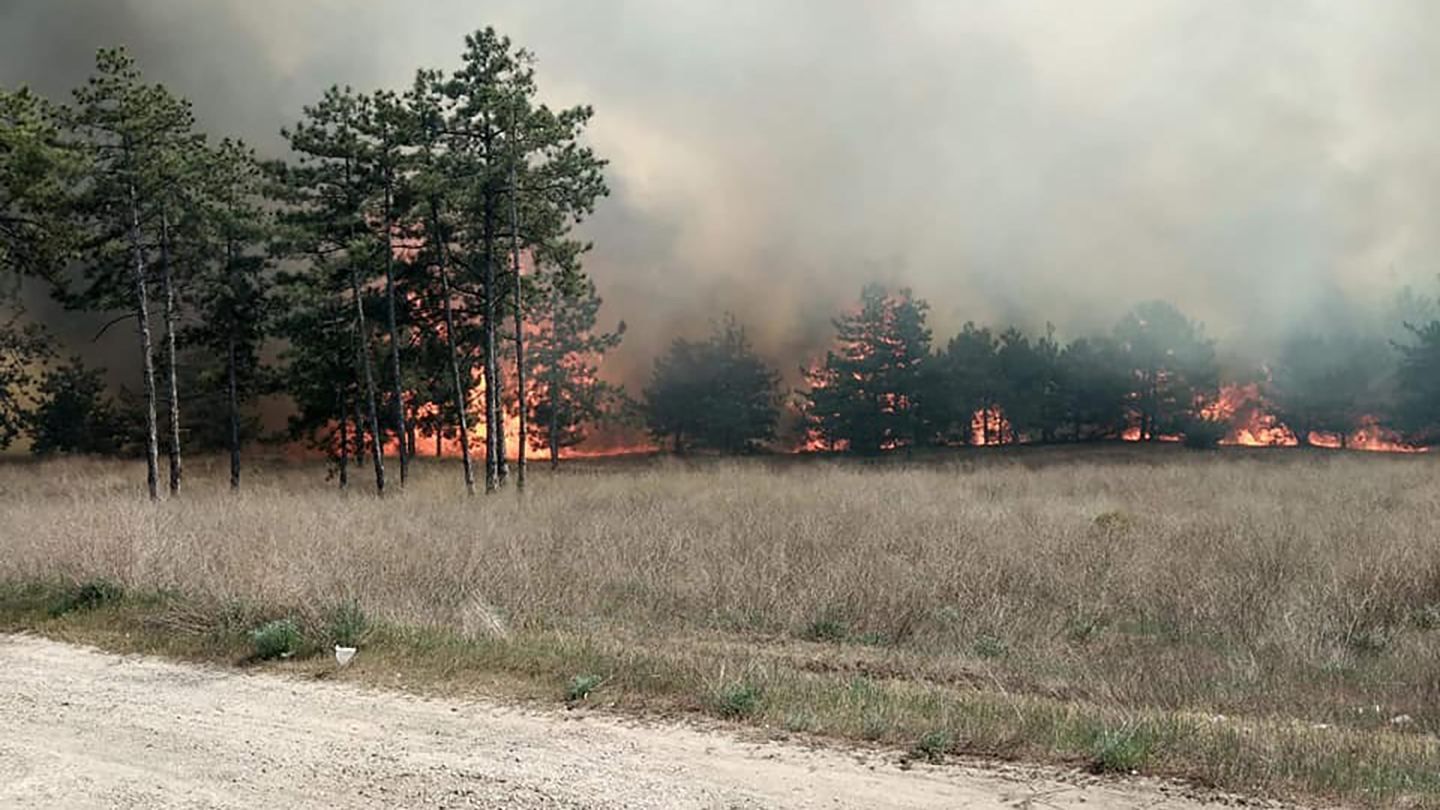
[0,29,624,497]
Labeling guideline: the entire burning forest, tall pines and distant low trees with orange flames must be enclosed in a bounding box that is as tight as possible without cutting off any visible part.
[8,29,1440,497]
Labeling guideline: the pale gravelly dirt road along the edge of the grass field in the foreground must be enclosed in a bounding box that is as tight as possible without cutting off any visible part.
[0,636,1238,809]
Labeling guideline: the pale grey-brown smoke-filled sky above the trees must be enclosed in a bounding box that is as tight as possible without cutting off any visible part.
[0,0,1440,380]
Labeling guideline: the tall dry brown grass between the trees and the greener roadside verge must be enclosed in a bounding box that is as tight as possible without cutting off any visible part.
[0,448,1440,795]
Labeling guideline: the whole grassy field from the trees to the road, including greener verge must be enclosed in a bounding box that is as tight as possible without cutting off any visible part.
[0,447,1440,807]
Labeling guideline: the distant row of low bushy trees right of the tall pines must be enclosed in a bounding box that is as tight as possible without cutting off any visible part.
[645,285,1440,454]
